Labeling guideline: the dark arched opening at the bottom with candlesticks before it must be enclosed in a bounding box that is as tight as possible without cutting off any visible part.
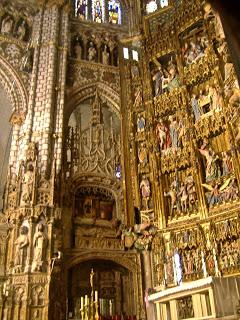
[68,258,139,320]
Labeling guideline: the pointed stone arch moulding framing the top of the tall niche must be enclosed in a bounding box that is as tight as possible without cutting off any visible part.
[65,82,120,122]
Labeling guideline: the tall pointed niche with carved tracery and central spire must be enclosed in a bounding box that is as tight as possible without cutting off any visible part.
[65,90,121,181]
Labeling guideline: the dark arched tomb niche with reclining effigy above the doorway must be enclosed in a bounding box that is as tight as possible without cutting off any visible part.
[73,186,122,250]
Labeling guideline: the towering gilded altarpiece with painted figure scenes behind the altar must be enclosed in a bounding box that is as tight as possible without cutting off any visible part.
[122,1,240,319]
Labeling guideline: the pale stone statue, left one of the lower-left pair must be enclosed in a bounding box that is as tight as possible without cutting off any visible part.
[14,226,29,273]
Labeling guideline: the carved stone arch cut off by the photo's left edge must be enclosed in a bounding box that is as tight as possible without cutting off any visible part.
[0,55,28,115]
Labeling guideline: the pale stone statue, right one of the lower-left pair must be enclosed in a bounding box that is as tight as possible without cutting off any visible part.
[32,223,47,272]
